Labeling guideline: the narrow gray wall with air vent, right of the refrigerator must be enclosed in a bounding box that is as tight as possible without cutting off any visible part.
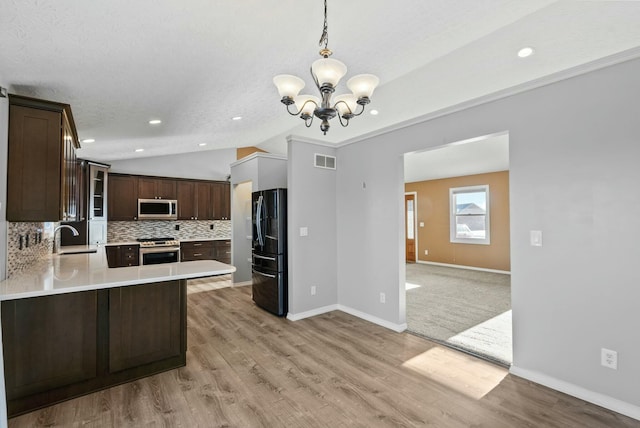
[287,137,342,320]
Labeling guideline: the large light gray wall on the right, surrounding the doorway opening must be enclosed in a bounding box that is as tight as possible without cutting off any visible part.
[322,59,640,418]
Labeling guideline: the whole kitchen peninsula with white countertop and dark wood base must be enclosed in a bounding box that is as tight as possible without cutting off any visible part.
[0,247,235,417]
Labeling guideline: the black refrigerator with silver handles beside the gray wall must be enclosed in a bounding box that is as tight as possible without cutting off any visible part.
[251,189,288,316]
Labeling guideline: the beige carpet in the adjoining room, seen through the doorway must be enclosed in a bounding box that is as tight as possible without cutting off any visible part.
[407,263,512,366]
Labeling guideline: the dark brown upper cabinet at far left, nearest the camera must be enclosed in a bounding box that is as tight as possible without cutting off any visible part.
[7,95,81,222]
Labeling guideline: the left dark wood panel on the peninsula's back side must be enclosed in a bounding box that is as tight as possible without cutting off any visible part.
[2,291,98,414]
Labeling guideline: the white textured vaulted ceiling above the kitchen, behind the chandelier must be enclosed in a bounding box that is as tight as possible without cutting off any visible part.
[0,0,640,162]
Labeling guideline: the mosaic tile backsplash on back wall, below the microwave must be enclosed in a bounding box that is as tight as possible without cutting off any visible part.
[107,220,231,242]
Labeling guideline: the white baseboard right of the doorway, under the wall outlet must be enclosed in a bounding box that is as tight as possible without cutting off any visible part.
[509,366,640,420]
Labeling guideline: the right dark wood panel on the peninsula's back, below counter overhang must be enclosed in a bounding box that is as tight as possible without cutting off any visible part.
[109,281,186,372]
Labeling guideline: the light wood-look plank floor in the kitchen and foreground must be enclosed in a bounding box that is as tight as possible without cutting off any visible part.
[9,284,640,428]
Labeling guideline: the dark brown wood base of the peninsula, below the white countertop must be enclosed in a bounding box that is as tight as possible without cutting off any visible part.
[2,280,187,417]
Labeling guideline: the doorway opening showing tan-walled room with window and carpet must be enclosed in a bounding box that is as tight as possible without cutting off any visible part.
[404,132,512,366]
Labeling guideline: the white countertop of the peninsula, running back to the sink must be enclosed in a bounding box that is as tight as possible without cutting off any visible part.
[0,246,236,301]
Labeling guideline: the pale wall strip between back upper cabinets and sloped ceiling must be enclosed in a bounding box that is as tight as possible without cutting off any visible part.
[109,149,236,181]
